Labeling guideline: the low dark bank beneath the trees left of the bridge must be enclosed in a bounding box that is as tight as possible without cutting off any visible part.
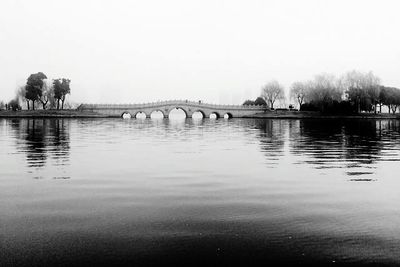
[0,109,106,118]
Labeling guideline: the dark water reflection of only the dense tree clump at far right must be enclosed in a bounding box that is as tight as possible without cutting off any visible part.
[290,120,399,175]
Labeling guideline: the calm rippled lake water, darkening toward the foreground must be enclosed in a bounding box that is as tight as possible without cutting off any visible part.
[0,119,400,266]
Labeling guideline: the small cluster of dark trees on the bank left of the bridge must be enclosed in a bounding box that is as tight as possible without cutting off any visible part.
[0,72,71,111]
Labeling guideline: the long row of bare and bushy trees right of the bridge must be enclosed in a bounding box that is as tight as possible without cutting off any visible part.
[243,70,400,114]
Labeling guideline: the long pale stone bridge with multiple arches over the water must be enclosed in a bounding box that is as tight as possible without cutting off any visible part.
[78,100,267,118]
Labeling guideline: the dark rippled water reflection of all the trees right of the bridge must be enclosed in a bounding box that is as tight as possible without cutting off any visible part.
[241,119,400,179]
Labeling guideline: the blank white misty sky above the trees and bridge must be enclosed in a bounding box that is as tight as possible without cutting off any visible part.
[0,0,400,103]
